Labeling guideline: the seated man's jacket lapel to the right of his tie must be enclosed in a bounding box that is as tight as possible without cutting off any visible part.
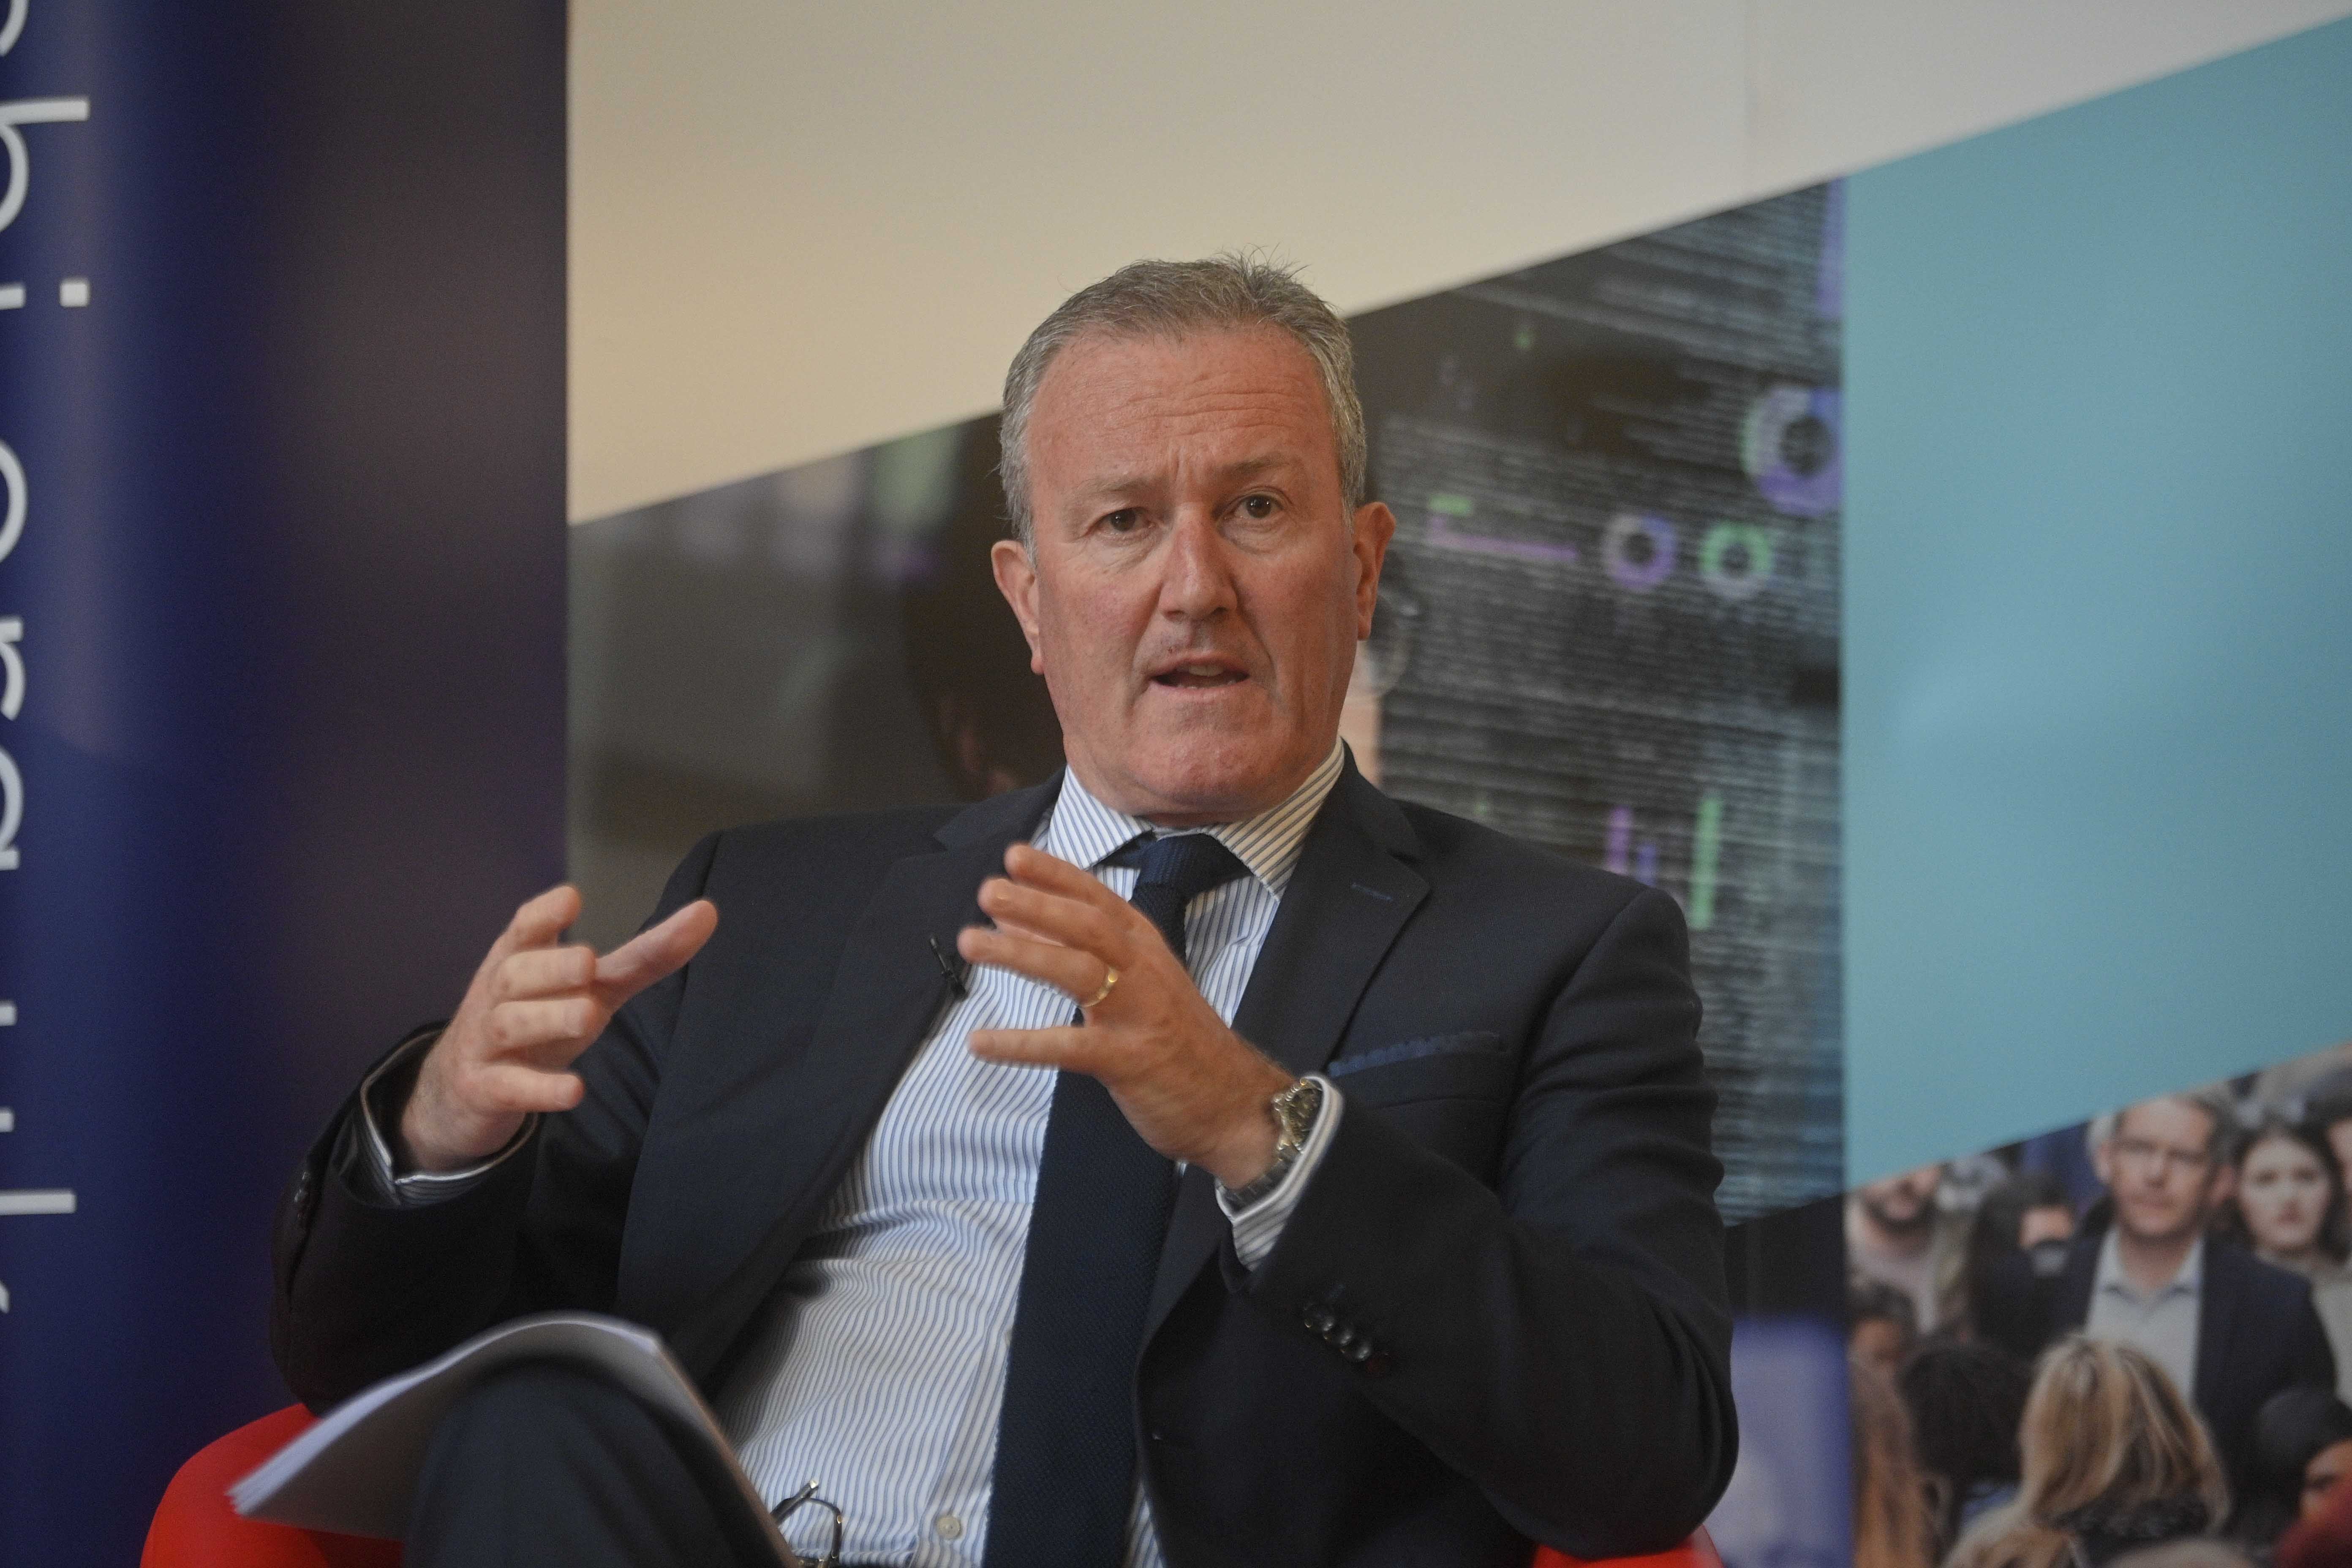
[1143,760,1430,1338]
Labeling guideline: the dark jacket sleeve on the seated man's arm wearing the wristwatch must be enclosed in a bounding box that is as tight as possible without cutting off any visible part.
[1230,889,1738,1556]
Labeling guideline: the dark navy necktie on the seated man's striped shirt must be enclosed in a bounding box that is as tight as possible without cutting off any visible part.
[988,832,1247,1568]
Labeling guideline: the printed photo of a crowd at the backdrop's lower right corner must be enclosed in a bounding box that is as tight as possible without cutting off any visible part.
[1844,1044,2352,1568]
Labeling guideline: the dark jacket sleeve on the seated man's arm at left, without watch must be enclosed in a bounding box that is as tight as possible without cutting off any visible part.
[270,835,717,1410]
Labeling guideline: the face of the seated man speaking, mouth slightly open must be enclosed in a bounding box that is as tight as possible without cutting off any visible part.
[995,329,1395,828]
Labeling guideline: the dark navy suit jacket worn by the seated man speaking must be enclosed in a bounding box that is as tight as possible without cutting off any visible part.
[273,766,1738,1568]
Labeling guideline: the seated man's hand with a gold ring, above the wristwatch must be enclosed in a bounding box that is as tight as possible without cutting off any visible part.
[955,844,1293,1190]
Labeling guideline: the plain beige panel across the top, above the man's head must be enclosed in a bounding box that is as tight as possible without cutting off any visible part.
[572,0,2352,517]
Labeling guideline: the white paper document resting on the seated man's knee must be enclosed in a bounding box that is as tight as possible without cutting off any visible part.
[228,1312,792,1565]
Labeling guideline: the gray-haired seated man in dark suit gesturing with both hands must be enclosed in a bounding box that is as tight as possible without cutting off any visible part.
[273,261,1736,1568]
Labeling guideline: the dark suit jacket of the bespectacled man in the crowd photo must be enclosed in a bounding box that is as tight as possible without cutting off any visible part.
[1980,1230,2336,1497]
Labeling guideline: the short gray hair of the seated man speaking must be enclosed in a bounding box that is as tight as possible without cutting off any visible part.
[997,251,1364,548]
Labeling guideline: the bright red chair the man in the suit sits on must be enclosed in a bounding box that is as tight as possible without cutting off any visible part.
[152,1406,1724,1568]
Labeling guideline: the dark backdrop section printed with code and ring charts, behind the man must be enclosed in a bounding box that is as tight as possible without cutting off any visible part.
[572,186,1842,1218]
